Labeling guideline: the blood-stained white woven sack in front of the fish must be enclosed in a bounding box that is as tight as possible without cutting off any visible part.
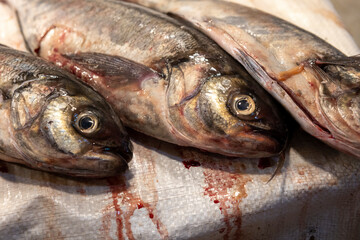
[0,131,360,239]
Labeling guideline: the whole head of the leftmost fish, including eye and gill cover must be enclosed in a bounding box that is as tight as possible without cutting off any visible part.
[11,76,132,177]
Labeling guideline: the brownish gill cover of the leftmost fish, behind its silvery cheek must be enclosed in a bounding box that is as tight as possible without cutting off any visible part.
[11,79,75,168]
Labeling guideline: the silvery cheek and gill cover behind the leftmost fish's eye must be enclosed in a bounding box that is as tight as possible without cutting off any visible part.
[11,87,90,167]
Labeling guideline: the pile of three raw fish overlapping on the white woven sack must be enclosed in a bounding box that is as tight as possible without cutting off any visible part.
[0,0,360,177]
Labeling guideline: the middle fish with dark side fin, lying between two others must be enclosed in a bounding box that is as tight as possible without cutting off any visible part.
[8,0,287,157]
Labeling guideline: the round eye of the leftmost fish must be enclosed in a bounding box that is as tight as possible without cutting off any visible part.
[75,111,99,134]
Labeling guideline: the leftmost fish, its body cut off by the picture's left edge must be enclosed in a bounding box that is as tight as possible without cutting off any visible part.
[0,45,132,177]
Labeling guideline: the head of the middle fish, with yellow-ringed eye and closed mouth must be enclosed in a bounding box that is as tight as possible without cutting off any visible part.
[178,75,288,157]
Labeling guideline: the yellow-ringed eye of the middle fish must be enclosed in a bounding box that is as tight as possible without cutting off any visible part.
[228,93,256,117]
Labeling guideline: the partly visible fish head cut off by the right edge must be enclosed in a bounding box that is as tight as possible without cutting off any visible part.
[315,63,360,142]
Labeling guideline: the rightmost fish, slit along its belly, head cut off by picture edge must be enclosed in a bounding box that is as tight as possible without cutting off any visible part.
[124,0,360,157]
